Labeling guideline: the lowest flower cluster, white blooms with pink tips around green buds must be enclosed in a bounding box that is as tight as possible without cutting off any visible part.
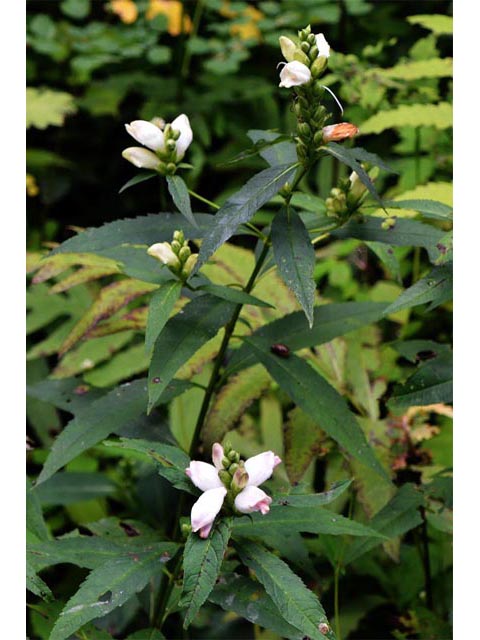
[185,442,281,538]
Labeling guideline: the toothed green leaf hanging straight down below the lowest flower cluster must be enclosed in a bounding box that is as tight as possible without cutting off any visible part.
[180,520,231,629]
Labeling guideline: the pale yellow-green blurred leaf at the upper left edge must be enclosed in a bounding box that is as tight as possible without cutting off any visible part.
[26,87,77,129]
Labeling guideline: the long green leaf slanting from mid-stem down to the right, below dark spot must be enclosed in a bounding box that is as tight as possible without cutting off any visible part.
[244,337,385,476]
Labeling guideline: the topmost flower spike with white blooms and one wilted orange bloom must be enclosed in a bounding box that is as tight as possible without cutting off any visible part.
[280,26,358,164]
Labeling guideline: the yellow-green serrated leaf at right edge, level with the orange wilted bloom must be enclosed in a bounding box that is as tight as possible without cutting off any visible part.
[360,102,453,135]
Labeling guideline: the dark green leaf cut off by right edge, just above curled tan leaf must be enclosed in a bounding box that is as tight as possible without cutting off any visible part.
[388,351,453,409]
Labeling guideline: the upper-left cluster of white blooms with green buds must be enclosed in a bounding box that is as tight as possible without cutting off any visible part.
[122,113,193,175]
